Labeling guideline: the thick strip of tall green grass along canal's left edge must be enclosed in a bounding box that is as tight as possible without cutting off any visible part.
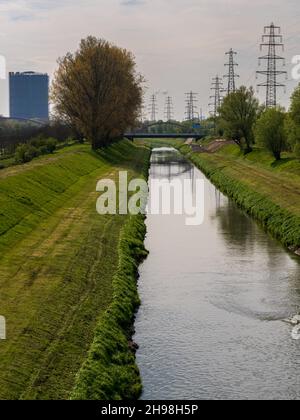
[71,215,148,400]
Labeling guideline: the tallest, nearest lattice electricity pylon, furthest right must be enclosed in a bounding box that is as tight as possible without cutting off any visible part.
[257,23,287,108]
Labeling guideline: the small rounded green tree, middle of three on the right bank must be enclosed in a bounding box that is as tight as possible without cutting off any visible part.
[255,108,288,160]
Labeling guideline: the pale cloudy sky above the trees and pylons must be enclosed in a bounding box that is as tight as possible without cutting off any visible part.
[0,0,300,120]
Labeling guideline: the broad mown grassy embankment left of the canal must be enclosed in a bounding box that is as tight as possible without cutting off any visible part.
[0,141,149,399]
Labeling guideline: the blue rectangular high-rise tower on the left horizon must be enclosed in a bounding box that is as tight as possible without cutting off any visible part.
[9,72,49,120]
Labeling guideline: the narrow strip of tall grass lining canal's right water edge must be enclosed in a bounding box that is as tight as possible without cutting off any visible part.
[180,146,300,255]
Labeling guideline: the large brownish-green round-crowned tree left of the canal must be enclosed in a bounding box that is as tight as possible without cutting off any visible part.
[52,36,143,149]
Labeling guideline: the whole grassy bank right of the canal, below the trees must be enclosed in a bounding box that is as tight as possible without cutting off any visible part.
[179,144,300,255]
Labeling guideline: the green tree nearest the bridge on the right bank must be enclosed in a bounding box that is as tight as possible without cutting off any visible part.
[218,86,260,154]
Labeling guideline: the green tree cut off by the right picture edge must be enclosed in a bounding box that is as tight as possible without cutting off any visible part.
[285,85,300,157]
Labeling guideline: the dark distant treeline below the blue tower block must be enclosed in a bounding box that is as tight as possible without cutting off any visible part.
[0,121,77,156]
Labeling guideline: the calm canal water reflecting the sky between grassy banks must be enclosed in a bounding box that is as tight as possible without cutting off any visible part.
[135,149,300,400]
